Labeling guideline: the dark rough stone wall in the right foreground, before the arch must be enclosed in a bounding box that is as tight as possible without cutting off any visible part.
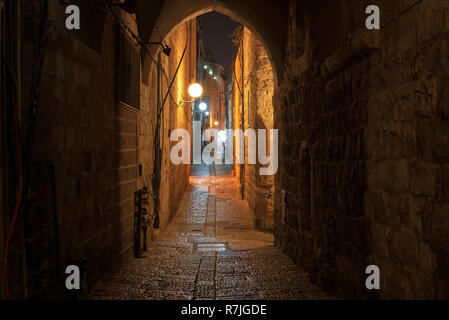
[275,0,449,298]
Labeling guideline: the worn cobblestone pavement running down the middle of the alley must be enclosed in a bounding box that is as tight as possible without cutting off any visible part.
[91,166,329,300]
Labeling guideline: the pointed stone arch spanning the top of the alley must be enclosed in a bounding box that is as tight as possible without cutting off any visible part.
[136,0,288,87]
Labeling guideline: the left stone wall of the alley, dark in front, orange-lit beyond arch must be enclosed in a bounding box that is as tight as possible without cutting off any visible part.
[2,0,196,297]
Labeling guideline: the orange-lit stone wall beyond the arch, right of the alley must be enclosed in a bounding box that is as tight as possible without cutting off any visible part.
[233,27,274,231]
